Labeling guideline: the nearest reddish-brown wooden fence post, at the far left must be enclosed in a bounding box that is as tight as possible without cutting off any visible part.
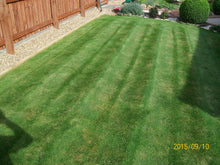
[0,0,15,54]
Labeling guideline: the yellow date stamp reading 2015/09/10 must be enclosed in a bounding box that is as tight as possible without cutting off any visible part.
[173,143,209,150]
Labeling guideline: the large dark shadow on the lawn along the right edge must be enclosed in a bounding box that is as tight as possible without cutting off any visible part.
[178,29,220,117]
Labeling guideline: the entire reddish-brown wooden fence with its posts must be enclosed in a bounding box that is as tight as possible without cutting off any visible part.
[0,0,108,54]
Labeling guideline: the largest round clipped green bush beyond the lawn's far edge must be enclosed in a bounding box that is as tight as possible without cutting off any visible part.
[180,0,210,23]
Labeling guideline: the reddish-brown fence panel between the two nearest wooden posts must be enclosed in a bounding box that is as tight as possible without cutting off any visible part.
[7,0,52,40]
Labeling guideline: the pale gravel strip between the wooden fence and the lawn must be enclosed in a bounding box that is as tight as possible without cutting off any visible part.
[0,5,116,76]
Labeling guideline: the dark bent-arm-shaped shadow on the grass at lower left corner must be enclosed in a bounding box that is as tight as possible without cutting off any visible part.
[0,109,33,165]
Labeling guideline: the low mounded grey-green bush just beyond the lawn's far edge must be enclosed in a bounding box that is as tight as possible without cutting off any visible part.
[121,3,143,15]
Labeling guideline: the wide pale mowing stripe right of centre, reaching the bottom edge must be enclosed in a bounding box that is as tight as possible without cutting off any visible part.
[128,25,173,164]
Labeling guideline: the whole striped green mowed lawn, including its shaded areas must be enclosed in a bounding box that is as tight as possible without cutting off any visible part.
[0,16,220,165]
